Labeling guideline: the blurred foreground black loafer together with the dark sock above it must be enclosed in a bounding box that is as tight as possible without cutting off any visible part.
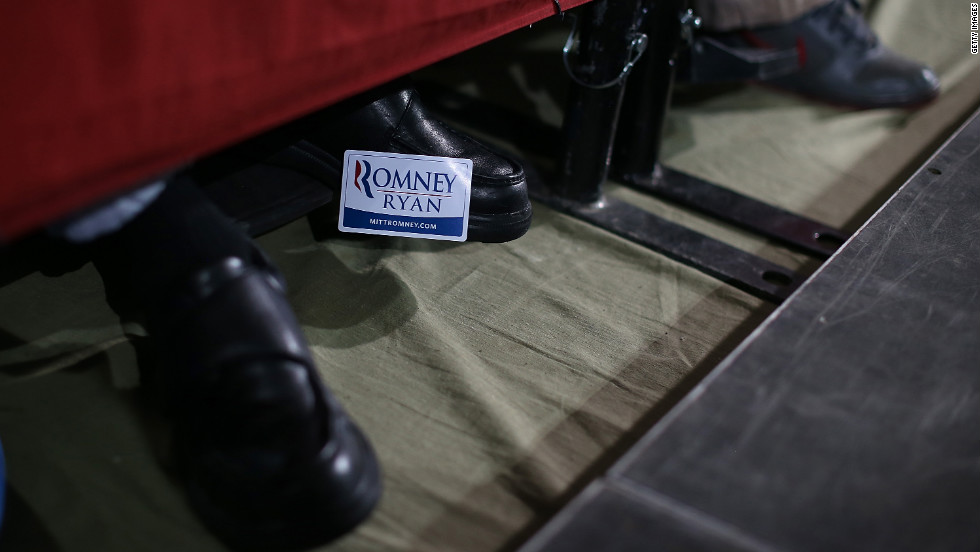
[95,185,381,550]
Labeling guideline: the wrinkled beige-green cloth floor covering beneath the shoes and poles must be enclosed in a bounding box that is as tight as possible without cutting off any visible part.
[0,0,980,552]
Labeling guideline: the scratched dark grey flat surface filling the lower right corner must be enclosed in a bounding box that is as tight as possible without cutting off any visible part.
[524,110,980,552]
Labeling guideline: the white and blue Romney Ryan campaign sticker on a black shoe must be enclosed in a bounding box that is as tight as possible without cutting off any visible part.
[338,150,473,241]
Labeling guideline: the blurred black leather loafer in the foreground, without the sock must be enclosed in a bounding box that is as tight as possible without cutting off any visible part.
[167,257,381,550]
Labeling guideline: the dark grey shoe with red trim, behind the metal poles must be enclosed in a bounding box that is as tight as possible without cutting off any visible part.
[712,0,939,109]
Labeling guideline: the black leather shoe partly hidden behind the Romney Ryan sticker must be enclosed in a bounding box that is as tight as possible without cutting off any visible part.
[306,80,531,242]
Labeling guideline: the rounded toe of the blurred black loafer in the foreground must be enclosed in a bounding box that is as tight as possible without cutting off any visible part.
[177,360,381,550]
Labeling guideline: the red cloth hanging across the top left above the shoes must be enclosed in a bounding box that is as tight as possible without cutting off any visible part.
[0,0,587,240]
